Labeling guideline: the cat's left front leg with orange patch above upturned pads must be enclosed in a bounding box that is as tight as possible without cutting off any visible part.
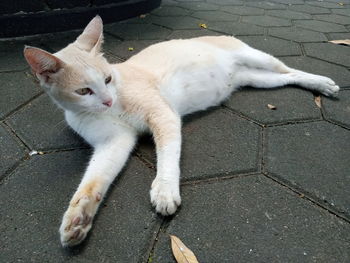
[59,132,136,246]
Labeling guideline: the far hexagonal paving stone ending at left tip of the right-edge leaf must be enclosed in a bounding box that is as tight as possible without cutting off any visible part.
[269,27,327,42]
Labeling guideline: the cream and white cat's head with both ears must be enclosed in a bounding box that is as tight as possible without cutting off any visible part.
[24,16,118,112]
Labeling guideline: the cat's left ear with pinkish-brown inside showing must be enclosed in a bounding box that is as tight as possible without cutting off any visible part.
[24,46,64,80]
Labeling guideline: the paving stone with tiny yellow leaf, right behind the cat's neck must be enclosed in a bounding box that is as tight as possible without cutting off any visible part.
[108,40,160,59]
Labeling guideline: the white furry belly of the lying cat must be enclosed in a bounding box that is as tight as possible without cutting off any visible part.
[161,54,237,116]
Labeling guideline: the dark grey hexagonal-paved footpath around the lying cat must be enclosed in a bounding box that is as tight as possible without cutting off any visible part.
[0,0,350,263]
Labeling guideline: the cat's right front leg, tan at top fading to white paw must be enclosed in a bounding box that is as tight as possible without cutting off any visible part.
[149,106,181,216]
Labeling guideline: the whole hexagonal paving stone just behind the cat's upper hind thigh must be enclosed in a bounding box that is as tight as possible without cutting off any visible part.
[240,36,301,56]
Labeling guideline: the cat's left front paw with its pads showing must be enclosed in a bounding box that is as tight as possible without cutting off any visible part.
[59,195,100,247]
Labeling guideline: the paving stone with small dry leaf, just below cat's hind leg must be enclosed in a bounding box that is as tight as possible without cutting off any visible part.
[225,87,321,124]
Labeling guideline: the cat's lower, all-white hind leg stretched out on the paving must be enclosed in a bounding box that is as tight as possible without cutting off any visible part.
[235,68,339,96]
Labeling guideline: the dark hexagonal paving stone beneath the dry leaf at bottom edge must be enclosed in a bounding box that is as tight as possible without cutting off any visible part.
[152,176,350,263]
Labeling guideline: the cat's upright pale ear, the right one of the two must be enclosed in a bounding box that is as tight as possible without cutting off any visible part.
[74,15,103,54]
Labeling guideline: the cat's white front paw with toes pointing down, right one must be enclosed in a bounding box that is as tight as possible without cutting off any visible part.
[150,179,181,216]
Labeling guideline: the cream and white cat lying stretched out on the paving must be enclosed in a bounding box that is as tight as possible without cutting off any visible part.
[24,16,339,246]
